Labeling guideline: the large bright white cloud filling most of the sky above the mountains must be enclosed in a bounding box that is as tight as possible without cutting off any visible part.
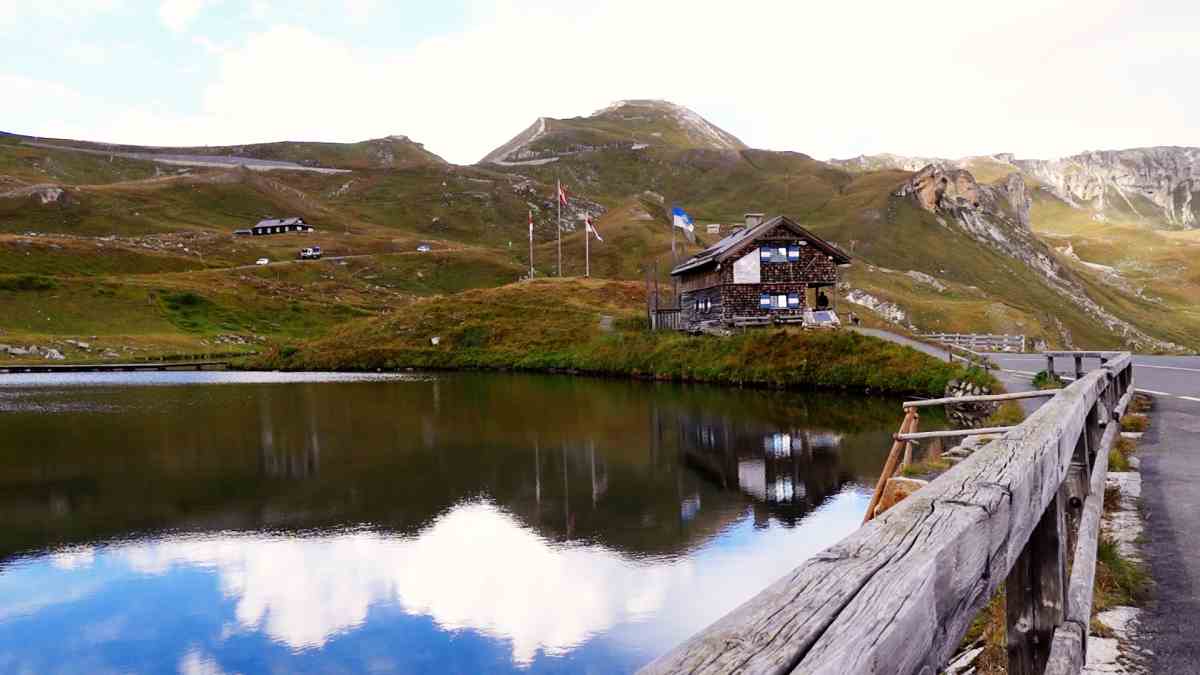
[10,0,1200,162]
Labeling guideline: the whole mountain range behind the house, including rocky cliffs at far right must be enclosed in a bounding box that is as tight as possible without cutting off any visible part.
[0,100,1200,350]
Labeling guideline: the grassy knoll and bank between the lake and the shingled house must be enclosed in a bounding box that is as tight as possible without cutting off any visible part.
[253,279,990,395]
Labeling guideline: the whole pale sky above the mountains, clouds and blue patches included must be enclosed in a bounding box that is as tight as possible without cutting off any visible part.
[0,0,1200,163]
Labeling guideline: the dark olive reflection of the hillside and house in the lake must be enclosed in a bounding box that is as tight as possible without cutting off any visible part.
[0,375,936,558]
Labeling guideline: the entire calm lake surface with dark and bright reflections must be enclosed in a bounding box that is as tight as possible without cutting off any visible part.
[0,372,926,674]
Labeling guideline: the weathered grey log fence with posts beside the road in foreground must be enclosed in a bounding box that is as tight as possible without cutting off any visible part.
[643,353,1134,675]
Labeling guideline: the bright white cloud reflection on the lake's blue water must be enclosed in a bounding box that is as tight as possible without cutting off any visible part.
[77,491,862,665]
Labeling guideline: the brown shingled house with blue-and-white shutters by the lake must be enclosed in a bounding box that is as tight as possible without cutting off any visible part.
[671,214,850,330]
